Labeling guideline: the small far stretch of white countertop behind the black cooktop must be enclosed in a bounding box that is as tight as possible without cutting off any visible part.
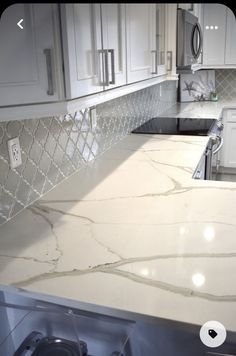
[161,100,236,119]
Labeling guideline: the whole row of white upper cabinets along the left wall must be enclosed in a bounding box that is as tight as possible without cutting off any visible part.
[0,3,177,111]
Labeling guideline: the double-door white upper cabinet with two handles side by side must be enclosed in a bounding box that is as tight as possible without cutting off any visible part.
[61,3,126,99]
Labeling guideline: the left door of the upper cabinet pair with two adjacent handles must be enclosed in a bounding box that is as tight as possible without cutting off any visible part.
[61,3,103,99]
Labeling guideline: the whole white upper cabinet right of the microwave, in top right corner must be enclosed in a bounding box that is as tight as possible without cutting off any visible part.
[203,4,236,67]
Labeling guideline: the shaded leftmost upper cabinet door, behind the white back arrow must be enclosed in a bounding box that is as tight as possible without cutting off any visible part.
[0,4,59,106]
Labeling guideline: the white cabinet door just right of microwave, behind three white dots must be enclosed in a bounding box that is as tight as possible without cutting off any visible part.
[203,4,226,65]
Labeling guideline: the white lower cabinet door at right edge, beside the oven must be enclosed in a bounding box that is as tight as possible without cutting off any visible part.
[223,122,236,168]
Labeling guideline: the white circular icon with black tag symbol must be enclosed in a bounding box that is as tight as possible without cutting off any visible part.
[200,320,226,347]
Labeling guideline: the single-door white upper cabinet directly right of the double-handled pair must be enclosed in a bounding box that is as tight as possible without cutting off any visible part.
[126,4,167,83]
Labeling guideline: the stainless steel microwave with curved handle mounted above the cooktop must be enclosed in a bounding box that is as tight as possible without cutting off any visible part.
[176,9,203,70]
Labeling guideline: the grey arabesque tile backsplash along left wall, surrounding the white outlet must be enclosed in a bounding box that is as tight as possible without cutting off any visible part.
[0,81,176,224]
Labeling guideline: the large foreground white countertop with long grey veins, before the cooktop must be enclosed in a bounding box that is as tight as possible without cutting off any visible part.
[0,134,236,331]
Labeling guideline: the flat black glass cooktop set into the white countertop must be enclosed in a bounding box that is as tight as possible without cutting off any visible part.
[132,117,216,136]
